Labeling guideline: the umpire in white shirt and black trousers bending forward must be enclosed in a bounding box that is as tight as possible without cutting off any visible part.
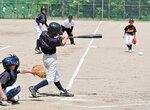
[62,15,75,45]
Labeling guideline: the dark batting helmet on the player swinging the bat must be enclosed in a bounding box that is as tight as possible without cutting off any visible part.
[47,22,63,36]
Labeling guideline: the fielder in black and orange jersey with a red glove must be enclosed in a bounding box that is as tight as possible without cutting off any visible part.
[123,19,136,53]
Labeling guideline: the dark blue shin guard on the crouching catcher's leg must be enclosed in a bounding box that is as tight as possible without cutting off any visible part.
[6,86,21,100]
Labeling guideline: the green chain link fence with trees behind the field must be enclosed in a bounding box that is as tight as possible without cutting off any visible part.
[0,0,150,20]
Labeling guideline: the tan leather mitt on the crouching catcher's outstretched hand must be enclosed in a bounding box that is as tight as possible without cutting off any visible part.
[31,65,46,78]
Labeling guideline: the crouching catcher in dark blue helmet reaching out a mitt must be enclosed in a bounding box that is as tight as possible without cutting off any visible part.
[0,55,31,106]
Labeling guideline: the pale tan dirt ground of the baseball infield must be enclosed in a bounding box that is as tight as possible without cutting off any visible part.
[0,20,150,110]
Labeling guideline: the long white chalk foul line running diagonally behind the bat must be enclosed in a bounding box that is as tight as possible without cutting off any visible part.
[66,21,102,90]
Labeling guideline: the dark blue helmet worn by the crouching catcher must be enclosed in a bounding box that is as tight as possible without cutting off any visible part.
[2,56,19,70]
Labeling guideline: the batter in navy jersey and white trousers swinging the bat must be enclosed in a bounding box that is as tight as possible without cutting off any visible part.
[29,22,74,98]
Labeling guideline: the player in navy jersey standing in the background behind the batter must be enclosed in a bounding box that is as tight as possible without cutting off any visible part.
[35,6,48,54]
